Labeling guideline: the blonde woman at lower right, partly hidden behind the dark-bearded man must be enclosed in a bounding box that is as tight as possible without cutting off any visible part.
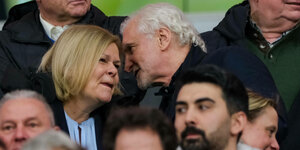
[238,90,279,150]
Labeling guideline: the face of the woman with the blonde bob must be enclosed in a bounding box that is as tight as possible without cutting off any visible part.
[82,43,121,104]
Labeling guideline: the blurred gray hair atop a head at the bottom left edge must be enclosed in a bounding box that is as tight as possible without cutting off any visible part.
[22,130,82,150]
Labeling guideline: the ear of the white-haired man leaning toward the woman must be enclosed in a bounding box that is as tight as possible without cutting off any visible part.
[157,27,172,50]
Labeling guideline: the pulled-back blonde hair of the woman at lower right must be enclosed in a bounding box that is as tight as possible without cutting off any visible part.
[247,89,276,122]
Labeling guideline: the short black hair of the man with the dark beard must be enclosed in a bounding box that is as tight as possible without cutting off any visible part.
[176,65,248,116]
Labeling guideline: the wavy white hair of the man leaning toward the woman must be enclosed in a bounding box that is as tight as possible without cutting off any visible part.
[120,3,206,52]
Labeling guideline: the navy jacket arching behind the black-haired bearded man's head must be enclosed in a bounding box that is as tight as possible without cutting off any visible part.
[203,46,287,129]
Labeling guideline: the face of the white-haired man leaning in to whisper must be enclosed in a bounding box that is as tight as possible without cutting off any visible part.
[122,20,161,89]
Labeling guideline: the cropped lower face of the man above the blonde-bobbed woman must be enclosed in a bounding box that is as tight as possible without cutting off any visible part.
[37,0,91,18]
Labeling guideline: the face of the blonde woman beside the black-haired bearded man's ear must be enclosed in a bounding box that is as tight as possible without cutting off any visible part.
[241,106,279,150]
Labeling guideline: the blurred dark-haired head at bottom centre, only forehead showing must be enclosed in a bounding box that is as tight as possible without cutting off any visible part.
[103,107,177,150]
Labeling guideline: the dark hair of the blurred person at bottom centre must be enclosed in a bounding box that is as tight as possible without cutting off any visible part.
[103,107,177,150]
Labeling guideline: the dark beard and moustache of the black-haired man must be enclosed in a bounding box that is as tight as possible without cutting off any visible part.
[180,126,210,150]
